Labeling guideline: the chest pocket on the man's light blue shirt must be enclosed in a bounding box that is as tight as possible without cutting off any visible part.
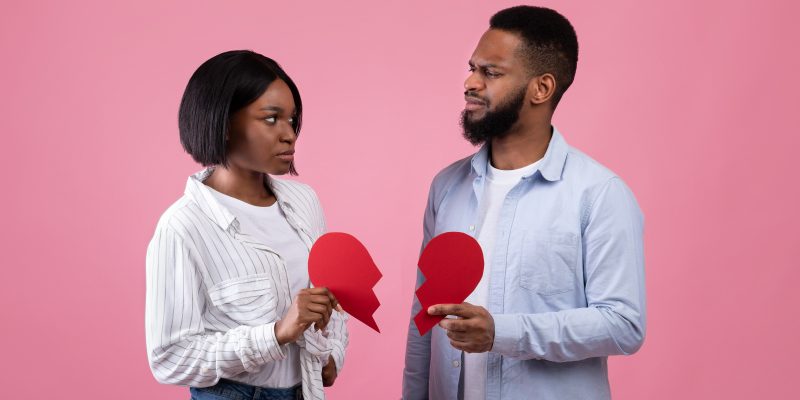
[519,231,578,296]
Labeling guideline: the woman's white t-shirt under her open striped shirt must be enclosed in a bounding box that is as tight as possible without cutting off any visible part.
[209,187,309,388]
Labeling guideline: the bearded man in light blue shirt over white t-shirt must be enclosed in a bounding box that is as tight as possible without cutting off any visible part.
[403,6,645,400]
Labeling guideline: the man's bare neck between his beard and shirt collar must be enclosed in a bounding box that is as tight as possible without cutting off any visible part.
[490,122,553,170]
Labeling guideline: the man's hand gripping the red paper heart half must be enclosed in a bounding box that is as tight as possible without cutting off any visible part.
[428,303,494,353]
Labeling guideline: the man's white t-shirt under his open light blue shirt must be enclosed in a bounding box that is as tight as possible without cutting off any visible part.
[464,161,539,400]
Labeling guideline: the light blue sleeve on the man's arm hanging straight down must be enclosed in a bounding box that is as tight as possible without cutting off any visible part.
[403,185,436,400]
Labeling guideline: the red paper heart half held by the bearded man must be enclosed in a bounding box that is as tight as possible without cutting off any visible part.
[414,232,483,336]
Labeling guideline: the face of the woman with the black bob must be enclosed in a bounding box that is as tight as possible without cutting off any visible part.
[228,79,297,175]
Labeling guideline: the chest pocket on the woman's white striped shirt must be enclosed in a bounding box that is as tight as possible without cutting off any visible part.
[208,274,277,326]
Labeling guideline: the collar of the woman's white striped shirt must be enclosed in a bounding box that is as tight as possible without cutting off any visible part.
[184,167,293,231]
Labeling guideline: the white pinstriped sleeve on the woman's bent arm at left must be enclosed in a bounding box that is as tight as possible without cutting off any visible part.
[145,227,286,387]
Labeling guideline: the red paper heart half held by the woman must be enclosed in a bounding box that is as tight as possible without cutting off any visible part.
[308,232,382,332]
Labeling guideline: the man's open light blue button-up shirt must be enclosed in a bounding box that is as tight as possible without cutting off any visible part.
[403,128,645,400]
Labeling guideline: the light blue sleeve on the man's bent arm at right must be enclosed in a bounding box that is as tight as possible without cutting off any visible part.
[492,177,645,362]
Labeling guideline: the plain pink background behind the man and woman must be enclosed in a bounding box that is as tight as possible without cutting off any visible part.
[0,1,800,399]
